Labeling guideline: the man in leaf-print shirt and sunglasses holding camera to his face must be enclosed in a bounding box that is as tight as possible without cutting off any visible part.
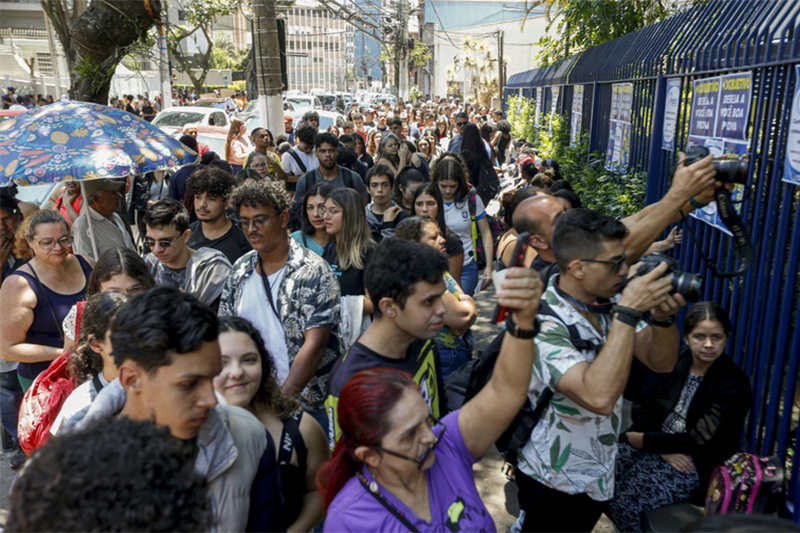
[516,209,686,531]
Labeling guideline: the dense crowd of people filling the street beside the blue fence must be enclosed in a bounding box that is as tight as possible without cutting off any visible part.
[0,93,780,532]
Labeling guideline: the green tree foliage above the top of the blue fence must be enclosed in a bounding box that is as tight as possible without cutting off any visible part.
[523,0,708,67]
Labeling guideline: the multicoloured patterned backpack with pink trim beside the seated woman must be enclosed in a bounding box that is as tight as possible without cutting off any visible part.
[706,453,784,515]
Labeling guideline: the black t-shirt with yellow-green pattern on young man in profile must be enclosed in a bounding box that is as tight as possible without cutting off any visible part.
[325,339,447,447]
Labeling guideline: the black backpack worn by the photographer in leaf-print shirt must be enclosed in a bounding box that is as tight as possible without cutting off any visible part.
[445,299,601,465]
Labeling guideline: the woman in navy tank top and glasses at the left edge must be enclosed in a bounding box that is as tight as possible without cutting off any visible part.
[0,209,92,391]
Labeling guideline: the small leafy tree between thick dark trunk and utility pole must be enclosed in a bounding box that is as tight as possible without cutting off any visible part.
[167,0,241,94]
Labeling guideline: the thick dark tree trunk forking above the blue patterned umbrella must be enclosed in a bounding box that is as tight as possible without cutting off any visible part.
[42,0,162,104]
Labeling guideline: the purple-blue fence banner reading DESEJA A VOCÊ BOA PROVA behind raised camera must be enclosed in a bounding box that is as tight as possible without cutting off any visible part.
[686,72,753,235]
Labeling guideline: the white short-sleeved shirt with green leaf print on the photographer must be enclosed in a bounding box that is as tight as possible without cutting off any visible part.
[517,276,646,501]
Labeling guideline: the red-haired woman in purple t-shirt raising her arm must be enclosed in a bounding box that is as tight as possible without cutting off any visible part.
[317,258,542,533]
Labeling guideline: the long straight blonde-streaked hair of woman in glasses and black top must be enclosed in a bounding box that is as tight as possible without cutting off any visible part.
[328,187,375,270]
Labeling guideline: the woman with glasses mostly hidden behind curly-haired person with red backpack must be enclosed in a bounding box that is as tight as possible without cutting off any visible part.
[61,247,156,348]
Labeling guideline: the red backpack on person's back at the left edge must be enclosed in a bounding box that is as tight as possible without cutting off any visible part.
[17,302,86,456]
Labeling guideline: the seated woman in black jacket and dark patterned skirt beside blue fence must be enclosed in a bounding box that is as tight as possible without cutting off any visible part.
[611,302,751,531]
